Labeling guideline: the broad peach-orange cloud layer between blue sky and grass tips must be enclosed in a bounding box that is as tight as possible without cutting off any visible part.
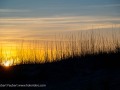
[0,16,120,39]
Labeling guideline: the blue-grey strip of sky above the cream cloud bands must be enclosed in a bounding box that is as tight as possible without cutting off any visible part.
[0,0,120,17]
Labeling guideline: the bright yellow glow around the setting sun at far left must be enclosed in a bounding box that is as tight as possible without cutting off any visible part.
[0,42,18,67]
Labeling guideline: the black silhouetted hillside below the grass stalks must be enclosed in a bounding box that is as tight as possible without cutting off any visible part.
[0,52,120,90]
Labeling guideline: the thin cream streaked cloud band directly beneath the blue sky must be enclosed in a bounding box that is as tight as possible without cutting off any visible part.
[0,16,120,24]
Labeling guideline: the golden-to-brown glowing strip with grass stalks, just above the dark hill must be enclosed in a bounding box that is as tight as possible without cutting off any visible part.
[0,28,120,66]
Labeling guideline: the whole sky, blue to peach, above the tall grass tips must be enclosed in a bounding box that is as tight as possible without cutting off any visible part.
[0,0,120,39]
